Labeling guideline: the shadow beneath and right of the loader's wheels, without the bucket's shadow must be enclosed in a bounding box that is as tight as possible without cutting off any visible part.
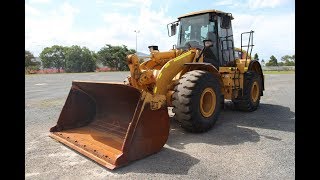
[167,103,295,149]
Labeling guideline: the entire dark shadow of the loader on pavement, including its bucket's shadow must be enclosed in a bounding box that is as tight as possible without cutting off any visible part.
[46,103,295,175]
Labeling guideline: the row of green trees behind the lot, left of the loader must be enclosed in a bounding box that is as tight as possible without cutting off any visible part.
[25,44,136,72]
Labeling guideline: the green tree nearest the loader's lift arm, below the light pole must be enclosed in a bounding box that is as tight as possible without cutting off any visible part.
[97,44,136,71]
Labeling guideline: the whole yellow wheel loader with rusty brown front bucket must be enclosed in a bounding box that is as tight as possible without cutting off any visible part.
[50,10,264,169]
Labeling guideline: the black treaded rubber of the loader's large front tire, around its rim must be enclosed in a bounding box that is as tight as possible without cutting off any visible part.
[172,70,223,132]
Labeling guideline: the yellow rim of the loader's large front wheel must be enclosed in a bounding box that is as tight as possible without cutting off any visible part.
[200,88,216,117]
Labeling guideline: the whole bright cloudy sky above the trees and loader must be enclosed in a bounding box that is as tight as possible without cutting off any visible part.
[25,0,295,61]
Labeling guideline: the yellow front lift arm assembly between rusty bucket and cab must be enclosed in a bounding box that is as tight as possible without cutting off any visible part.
[127,49,198,96]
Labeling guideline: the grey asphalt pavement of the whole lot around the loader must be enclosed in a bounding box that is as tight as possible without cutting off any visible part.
[25,72,295,180]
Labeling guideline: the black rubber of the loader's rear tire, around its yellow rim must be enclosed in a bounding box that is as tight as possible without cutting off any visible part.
[233,71,262,112]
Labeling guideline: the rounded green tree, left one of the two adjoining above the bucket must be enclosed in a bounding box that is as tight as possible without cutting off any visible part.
[40,45,68,72]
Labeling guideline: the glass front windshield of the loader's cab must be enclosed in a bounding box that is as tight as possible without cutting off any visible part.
[177,14,214,48]
